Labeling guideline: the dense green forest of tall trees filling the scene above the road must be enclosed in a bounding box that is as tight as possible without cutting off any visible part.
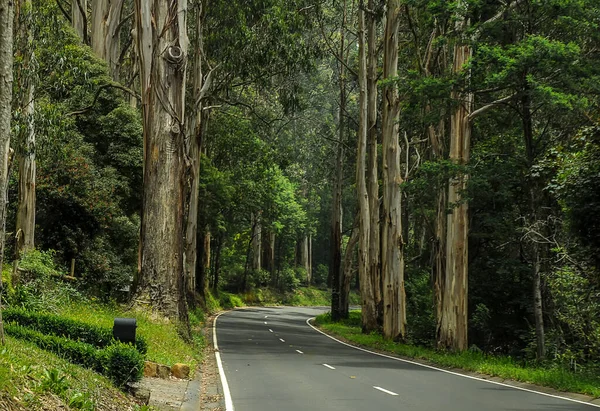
[0,0,600,366]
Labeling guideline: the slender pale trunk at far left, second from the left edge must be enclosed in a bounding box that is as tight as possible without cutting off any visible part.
[15,0,36,262]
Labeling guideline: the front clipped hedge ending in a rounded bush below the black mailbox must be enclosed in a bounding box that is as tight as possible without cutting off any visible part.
[4,323,144,387]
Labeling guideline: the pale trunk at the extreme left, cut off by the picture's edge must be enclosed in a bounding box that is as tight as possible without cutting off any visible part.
[0,0,14,345]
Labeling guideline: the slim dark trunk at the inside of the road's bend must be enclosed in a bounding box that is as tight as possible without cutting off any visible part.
[329,0,347,321]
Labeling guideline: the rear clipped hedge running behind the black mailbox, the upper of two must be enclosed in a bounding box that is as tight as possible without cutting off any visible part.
[2,309,148,355]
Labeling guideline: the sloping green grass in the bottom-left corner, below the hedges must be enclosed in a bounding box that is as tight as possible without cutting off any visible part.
[0,336,138,411]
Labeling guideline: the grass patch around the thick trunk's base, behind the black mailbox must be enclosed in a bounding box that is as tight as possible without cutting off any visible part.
[58,302,204,370]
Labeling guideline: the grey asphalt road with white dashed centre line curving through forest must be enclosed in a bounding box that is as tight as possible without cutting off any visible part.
[216,307,600,411]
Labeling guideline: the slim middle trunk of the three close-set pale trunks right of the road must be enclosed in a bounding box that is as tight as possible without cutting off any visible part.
[367,0,383,323]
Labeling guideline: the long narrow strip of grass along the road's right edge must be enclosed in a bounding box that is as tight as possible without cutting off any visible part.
[315,311,600,397]
